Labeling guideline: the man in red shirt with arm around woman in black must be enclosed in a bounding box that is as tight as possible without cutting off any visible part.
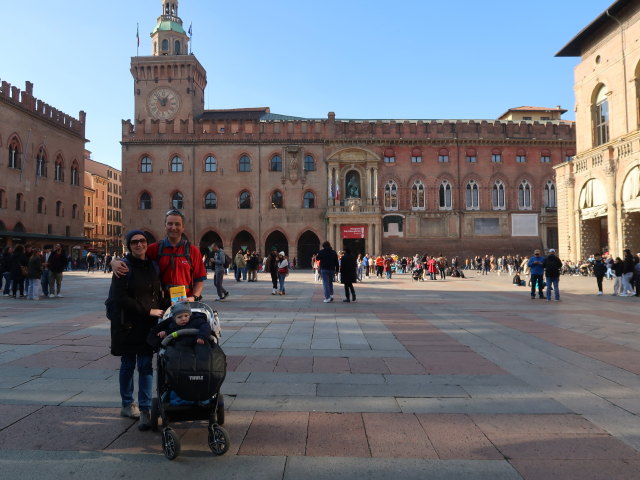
[111,210,207,302]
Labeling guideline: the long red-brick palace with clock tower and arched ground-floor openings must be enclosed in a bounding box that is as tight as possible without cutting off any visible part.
[122,0,575,266]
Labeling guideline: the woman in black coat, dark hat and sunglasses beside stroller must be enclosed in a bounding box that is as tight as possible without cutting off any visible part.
[111,230,169,430]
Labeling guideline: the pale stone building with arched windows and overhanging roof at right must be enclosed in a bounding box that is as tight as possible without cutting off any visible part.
[555,0,640,260]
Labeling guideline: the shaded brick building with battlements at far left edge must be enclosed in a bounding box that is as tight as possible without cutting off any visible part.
[0,81,86,250]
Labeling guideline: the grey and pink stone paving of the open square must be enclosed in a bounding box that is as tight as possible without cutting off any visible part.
[0,271,640,480]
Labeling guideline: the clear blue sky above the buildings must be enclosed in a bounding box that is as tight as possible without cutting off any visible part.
[0,0,612,168]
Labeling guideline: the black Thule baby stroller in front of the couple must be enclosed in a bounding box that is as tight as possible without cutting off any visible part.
[150,302,229,460]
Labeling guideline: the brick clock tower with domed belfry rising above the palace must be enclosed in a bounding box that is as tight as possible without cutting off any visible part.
[131,0,207,125]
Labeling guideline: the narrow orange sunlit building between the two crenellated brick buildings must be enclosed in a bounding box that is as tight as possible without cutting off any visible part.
[84,158,123,254]
